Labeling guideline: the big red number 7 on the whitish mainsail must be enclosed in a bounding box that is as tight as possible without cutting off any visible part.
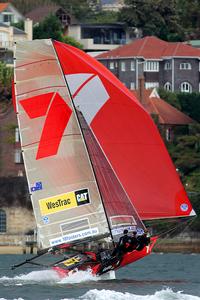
[20,92,72,159]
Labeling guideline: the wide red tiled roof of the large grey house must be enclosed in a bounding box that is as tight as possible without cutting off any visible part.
[97,36,200,59]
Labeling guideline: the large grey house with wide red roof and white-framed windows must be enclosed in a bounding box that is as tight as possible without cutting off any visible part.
[96,36,200,93]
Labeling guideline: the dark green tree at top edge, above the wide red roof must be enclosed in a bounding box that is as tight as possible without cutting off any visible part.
[120,0,183,40]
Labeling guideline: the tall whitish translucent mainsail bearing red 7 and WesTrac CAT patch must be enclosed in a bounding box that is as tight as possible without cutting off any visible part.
[14,40,109,248]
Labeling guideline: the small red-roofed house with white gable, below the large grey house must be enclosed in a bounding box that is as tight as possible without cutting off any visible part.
[131,76,195,141]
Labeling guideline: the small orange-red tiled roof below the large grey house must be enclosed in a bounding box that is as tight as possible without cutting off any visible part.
[131,89,195,125]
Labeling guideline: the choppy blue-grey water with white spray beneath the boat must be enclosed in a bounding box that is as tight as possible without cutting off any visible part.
[0,254,200,300]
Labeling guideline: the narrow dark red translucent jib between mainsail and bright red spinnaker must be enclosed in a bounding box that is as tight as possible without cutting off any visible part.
[77,111,144,237]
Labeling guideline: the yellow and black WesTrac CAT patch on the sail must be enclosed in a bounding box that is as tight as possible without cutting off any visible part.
[39,189,90,216]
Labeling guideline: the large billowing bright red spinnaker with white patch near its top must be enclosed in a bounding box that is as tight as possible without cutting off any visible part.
[54,42,194,219]
